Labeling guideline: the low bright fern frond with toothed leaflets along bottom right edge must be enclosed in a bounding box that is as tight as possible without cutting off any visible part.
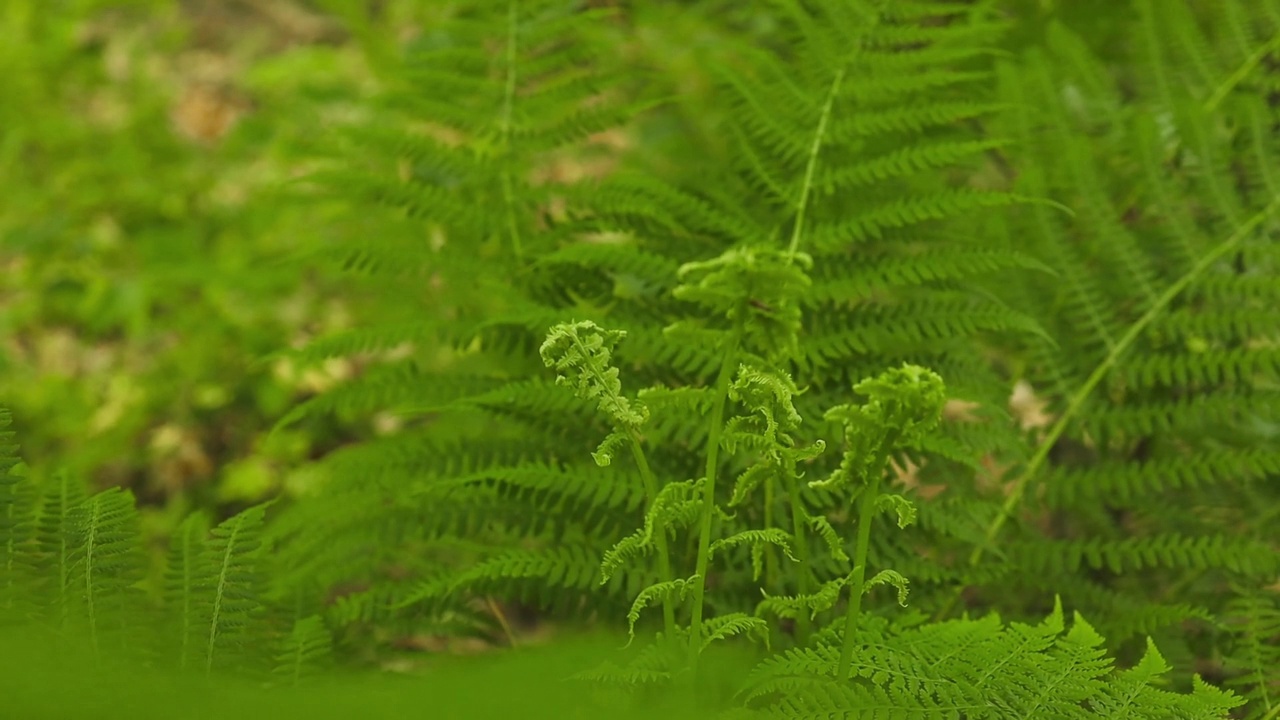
[745,605,1240,719]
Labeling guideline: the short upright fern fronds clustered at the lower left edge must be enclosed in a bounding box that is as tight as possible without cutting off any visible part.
[0,411,302,682]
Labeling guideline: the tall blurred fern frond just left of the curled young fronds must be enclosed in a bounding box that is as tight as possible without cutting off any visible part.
[261,1,654,650]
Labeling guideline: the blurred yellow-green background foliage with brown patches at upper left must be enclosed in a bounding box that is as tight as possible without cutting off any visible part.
[0,0,389,534]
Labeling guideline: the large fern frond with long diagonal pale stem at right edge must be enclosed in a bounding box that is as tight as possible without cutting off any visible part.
[940,1,1280,696]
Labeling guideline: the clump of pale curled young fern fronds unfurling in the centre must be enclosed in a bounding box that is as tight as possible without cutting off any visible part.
[540,247,945,702]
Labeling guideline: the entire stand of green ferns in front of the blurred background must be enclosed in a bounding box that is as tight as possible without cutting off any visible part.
[0,0,1280,719]
